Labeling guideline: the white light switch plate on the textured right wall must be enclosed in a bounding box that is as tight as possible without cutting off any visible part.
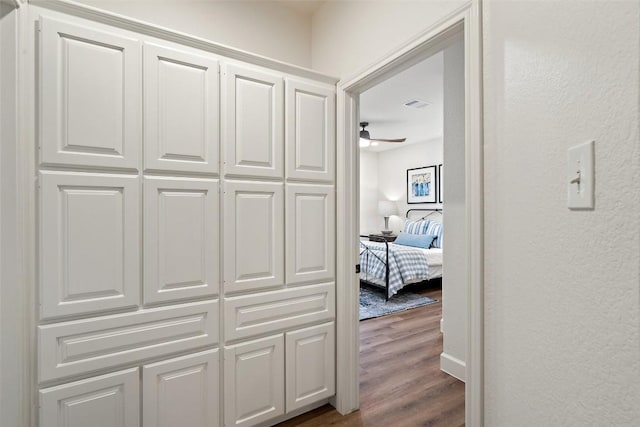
[567,141,595,209]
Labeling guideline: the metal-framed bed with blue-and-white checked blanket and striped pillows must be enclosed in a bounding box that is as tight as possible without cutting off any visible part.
[360,209,442,300]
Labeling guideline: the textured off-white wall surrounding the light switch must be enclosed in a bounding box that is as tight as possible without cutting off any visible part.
[484,1,640,427]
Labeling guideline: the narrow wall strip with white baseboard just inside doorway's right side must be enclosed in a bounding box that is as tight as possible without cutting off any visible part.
[441,36,469,380]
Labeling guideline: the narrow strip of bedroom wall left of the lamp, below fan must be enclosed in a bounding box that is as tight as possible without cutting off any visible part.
[360,151,384,235]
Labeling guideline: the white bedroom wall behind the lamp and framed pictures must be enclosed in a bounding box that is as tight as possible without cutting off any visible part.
[375,138,442,233]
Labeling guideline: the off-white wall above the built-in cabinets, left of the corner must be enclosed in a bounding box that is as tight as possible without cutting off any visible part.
[72,0,311,67]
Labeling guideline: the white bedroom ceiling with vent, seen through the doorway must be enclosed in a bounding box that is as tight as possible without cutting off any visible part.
[360,52,443,152]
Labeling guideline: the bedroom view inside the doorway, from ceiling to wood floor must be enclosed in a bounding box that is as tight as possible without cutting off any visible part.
[358,34,467,425]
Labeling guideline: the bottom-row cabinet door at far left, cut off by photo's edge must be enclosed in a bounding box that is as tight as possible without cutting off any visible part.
[39,368,140,427]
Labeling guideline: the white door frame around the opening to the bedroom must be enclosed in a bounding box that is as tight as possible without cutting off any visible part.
[334,0,484,427]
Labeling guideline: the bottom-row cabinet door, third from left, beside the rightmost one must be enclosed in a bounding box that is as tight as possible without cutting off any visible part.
[224,334,284,426]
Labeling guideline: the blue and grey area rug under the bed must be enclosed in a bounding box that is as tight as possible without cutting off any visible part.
[360,284,438,320]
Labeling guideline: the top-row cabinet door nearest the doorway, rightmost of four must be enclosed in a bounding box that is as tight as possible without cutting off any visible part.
[286,79,336,182]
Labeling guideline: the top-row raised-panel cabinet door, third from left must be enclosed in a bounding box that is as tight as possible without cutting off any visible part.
[223,65,284,178]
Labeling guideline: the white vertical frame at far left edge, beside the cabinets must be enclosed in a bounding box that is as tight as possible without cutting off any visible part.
[0,0,34,426]
